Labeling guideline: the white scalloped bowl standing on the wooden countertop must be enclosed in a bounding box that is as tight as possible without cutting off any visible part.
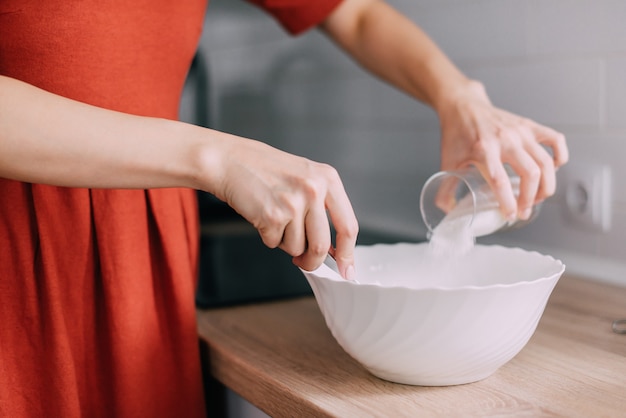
[303,243,565,386]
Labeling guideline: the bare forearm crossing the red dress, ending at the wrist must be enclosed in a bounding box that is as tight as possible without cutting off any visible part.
[0,76,224,188]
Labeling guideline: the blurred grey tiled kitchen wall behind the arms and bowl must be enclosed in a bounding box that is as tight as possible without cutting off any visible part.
[181,0,626,417]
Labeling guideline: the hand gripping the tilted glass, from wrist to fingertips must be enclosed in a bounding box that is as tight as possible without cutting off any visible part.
[437,81,569,219]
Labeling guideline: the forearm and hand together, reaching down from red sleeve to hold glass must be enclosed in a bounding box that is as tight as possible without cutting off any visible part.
[321,0,568,219]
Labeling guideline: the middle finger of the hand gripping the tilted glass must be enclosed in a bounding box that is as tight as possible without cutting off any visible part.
[503,148,541,220]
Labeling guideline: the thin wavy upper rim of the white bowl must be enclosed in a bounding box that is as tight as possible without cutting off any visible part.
[300,242,566,292]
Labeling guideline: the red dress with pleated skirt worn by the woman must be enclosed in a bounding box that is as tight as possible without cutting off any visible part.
[0,0,337,418]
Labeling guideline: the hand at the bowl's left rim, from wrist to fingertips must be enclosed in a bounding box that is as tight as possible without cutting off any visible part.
[205,136,358,279]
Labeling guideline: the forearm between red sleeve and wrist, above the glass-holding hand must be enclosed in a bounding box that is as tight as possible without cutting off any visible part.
[321,0,482,110]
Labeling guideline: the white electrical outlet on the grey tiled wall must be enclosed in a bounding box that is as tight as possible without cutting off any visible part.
[559,161,611,232]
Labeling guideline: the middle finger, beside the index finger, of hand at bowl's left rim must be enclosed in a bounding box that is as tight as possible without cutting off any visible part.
[293,202,331,271]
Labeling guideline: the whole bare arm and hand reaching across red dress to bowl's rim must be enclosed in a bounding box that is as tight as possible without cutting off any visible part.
[0,76,358,278]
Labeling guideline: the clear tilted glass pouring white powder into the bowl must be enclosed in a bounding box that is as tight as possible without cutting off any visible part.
[420,167,540,237]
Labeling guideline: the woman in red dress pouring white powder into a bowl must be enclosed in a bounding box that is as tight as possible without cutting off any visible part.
[0,0,567,417]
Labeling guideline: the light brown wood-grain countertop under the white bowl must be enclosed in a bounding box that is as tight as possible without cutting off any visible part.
[198,275,626,417]
